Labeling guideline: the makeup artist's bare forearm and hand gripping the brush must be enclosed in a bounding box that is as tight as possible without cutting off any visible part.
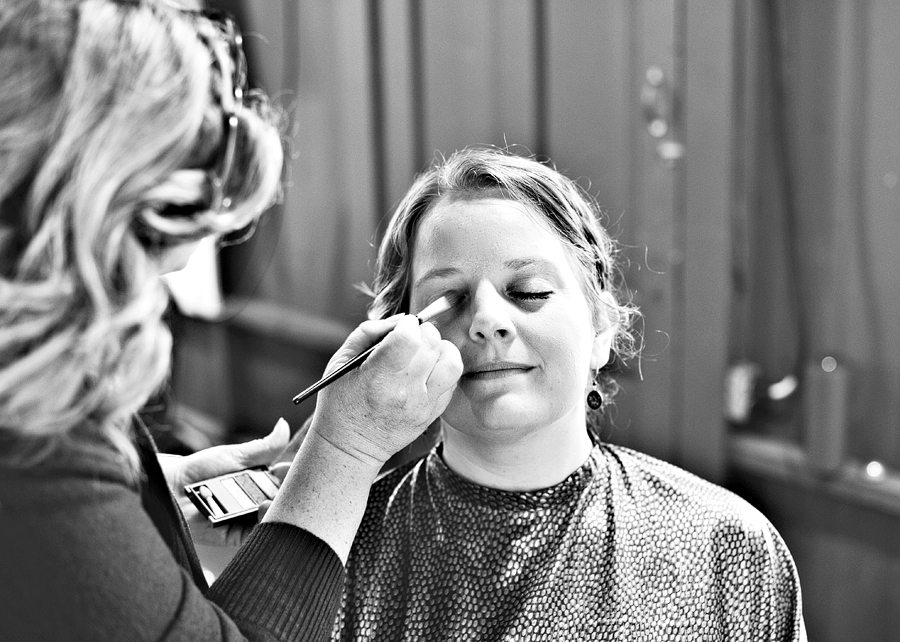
[263,315,462,562]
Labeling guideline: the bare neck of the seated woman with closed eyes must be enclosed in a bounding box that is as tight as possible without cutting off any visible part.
[443,412,593,492]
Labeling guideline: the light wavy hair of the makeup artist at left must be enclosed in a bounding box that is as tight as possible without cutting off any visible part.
[0,0,282,466]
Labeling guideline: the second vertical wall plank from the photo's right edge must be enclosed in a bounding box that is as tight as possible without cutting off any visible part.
[828,2,876,460]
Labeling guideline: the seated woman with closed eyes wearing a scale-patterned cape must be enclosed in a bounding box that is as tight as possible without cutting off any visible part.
[334,150,804,642]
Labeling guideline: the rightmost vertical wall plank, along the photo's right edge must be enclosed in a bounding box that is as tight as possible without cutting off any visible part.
[856,0,900,460]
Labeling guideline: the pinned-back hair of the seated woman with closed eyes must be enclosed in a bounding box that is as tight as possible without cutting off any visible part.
[369,147,637,416]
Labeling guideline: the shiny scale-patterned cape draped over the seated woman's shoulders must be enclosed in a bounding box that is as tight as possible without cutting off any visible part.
[333,444,805,642]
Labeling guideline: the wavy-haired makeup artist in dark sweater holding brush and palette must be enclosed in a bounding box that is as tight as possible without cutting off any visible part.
[0,0,461,641]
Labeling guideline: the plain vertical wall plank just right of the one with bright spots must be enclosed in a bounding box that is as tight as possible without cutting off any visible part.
[671,0,735,481]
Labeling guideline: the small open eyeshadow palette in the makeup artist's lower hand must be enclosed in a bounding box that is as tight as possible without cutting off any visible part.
[184,467,281,525]
